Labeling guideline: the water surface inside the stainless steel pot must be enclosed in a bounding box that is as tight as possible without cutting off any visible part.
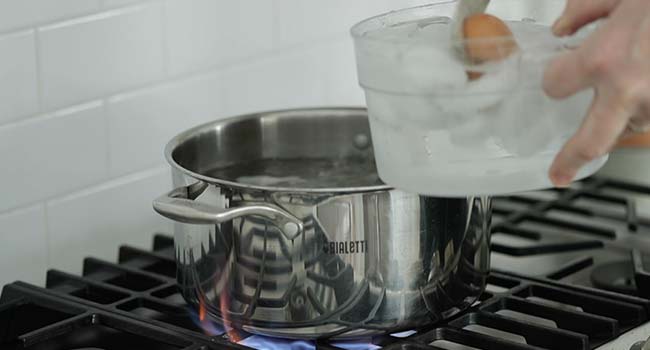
[206,157,383,188]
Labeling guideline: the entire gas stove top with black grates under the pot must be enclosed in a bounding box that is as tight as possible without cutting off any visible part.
[0,178,650,350]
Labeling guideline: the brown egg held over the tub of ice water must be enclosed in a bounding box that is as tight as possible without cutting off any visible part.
[463,13,518,80]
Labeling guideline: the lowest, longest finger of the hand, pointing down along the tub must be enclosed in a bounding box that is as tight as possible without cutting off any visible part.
[549,89,629,187]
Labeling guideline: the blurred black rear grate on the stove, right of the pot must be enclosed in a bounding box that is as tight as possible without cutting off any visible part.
[492,178,650,298]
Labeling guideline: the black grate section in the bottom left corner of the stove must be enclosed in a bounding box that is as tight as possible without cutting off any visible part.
[0,282,238,350]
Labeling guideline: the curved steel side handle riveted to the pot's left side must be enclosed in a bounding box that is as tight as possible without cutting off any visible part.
[153,184,303,239]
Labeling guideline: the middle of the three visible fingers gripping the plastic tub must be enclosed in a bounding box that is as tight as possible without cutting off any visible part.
[543,49,592,98]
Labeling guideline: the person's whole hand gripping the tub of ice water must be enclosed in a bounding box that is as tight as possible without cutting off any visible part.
[544,0,650,186]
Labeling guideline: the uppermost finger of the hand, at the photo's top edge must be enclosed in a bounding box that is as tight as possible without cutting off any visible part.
[553,0,622,36]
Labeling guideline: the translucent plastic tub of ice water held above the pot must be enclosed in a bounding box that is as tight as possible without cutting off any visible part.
[355,11,605,196]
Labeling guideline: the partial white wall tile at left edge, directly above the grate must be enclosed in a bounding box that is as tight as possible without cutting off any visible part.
[0,204,48,287]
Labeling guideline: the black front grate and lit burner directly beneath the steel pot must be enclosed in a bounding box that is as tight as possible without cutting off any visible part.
[0,236,650,350]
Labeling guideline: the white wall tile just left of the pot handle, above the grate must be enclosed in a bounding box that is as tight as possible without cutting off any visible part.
[47,167,171,273]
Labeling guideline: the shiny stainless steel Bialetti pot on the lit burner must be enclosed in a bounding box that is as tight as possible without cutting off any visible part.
[154,108,490,338]
